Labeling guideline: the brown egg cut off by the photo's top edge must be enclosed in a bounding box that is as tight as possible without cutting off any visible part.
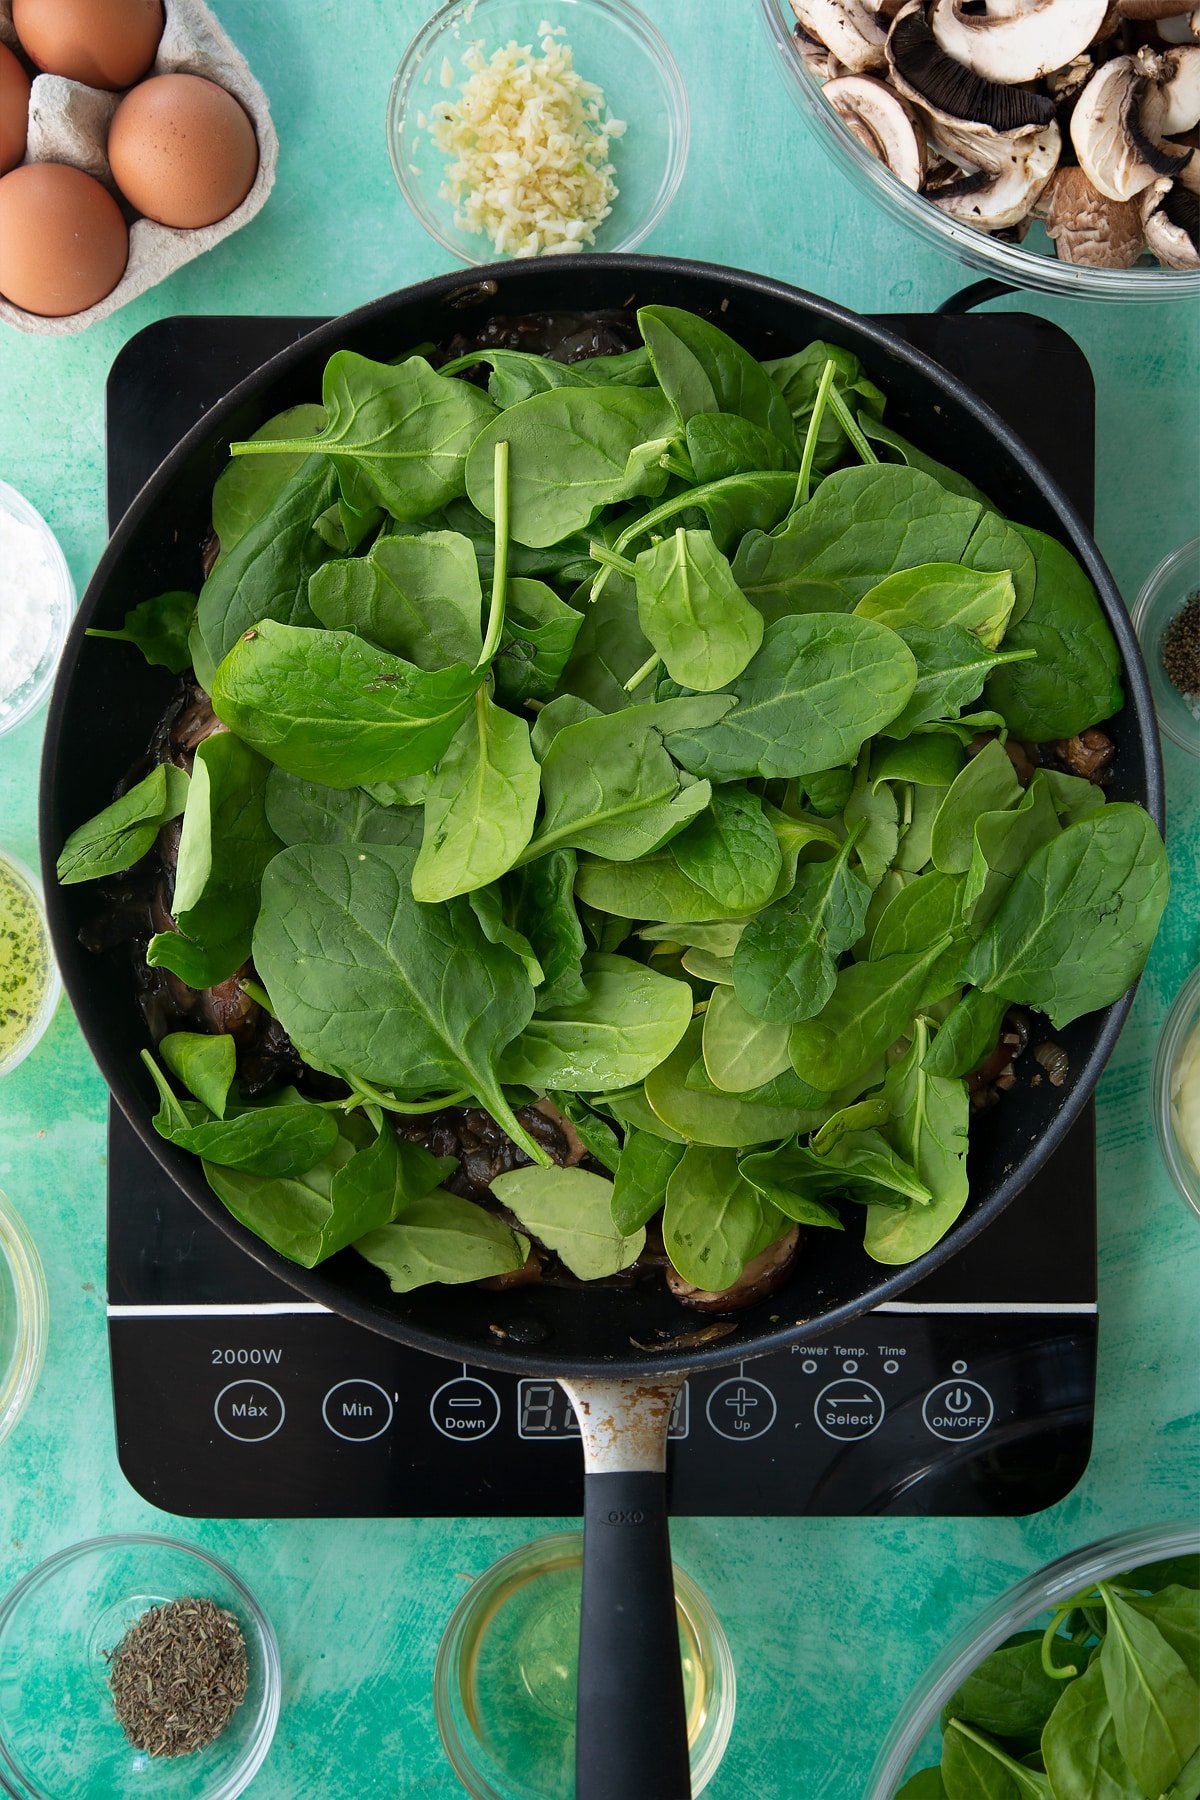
[13,0,162,88]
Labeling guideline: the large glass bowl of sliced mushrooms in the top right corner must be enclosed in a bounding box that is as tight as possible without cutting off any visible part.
[759,0,1200,301]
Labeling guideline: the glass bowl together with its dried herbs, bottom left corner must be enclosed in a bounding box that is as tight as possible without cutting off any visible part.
[0,1534,281,1800]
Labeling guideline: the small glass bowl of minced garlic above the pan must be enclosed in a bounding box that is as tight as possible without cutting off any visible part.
[387,0,691,263]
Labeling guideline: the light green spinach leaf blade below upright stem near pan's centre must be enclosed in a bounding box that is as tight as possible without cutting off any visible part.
[412,688,540,900]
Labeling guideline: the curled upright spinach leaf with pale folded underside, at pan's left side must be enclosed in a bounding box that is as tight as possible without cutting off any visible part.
[146,731,278,986]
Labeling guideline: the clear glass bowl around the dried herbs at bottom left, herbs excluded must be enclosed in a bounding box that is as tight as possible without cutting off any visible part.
[0,1534,281,1800]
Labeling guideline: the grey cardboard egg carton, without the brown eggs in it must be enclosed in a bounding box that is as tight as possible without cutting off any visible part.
[0,0,279,337]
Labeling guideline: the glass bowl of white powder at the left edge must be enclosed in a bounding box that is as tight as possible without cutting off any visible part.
[0,481,76,734]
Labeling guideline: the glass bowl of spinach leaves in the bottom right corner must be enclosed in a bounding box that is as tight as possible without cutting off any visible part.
[867,1525,1200,1800]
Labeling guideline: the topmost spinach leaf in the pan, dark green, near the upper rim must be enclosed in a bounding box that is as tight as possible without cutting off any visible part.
[637,306,793,443]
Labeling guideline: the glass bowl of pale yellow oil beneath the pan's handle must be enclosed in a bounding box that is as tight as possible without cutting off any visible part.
[434,1532,736,1800]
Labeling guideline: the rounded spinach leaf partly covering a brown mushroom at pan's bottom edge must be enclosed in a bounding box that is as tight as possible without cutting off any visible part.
[662,1145,786,1292]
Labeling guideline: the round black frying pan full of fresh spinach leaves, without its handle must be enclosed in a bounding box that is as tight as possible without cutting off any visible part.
[43,257,1166,1366]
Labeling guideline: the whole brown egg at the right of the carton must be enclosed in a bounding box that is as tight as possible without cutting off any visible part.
[108,76,259,230]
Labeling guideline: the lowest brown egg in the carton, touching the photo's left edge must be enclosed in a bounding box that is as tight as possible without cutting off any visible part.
[0,162,130,319]
